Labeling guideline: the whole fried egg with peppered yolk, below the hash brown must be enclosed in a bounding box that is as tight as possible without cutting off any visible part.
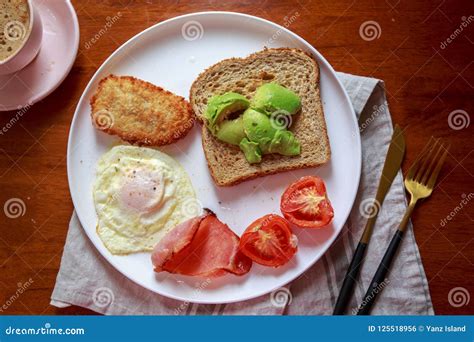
[93,145,201,254]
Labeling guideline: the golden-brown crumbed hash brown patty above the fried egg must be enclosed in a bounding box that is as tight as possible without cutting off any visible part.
[90,75,195,146]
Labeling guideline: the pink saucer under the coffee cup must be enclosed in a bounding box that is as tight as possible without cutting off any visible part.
[0,0,79,111]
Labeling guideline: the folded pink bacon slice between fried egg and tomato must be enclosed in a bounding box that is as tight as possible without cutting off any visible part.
[151,210,252,277]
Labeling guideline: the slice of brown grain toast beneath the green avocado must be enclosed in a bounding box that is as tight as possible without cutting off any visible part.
[189,48,331,186]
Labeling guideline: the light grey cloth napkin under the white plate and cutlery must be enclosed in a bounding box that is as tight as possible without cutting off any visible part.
[51,73,434,315]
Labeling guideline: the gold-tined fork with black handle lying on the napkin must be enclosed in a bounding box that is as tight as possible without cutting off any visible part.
[357,137,449,315]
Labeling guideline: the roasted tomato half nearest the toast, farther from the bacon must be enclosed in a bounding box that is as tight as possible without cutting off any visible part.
[280,176,334,228]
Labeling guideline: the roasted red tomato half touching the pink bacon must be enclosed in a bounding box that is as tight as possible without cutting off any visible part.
[239,214,298,267]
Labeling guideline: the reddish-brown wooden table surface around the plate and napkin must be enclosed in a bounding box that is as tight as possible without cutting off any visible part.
[0,0,474,315]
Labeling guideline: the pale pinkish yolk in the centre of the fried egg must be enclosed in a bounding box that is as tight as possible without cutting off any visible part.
[120,169,164,213]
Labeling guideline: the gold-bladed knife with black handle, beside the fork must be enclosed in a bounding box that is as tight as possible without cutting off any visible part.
[333,125,405,315]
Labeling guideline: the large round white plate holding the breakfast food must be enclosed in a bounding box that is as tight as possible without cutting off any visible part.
[67,12,361,303]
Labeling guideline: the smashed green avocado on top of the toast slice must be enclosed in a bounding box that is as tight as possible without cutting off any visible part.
[205,83,301,164]
